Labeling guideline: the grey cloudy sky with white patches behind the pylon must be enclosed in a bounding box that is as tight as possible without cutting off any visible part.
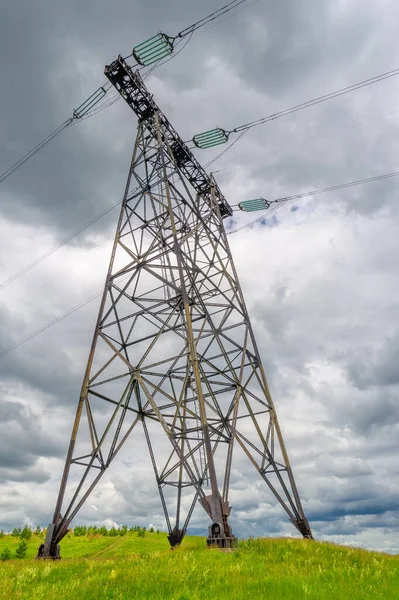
[0,0,399,552]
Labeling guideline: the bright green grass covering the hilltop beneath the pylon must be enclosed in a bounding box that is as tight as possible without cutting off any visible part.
[0,533,399,600]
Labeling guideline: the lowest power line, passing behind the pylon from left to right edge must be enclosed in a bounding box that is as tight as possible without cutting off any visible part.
[0,166,399,357]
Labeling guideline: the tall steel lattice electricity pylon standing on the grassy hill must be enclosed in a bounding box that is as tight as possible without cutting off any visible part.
[38,57,312,558]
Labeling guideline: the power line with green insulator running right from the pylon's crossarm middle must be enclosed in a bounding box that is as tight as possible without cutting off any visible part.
[192,68,399,149]
